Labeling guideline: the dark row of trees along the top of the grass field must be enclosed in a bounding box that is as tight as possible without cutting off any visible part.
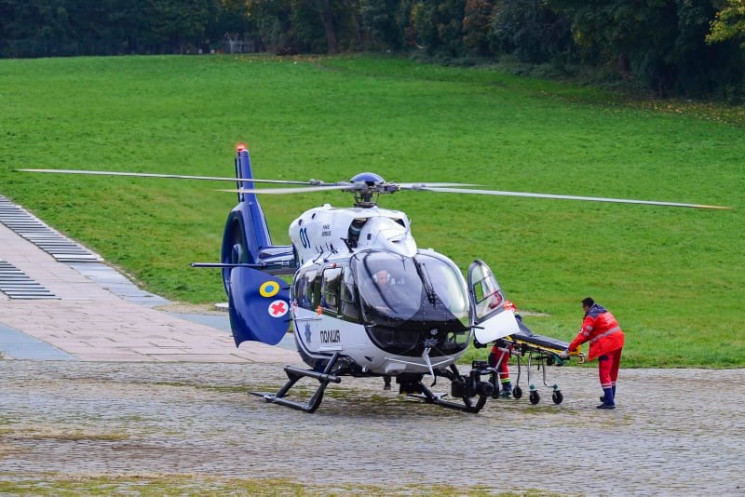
[0,0,745,99]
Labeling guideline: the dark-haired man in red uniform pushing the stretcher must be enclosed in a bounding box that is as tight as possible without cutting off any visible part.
[562,297,624,409]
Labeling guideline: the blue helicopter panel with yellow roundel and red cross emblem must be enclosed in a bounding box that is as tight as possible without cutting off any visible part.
[228,267,291,347]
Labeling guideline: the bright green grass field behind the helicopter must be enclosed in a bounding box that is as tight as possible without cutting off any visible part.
[0,56,745,367]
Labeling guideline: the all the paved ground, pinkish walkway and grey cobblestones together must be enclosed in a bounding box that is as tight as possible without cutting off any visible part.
[0,201,745,496]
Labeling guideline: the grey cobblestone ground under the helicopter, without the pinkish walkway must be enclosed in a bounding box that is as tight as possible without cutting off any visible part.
[0,361,745,496]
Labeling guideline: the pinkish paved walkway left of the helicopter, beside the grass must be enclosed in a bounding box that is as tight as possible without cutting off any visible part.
[0,215,300,364]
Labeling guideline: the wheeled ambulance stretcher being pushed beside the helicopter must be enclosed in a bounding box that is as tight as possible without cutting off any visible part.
[492,319,585,405]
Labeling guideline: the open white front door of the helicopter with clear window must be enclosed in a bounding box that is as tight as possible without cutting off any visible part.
[468,259,520,344]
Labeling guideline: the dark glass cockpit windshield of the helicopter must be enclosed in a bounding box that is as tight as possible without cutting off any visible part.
[352,252,469,327]
